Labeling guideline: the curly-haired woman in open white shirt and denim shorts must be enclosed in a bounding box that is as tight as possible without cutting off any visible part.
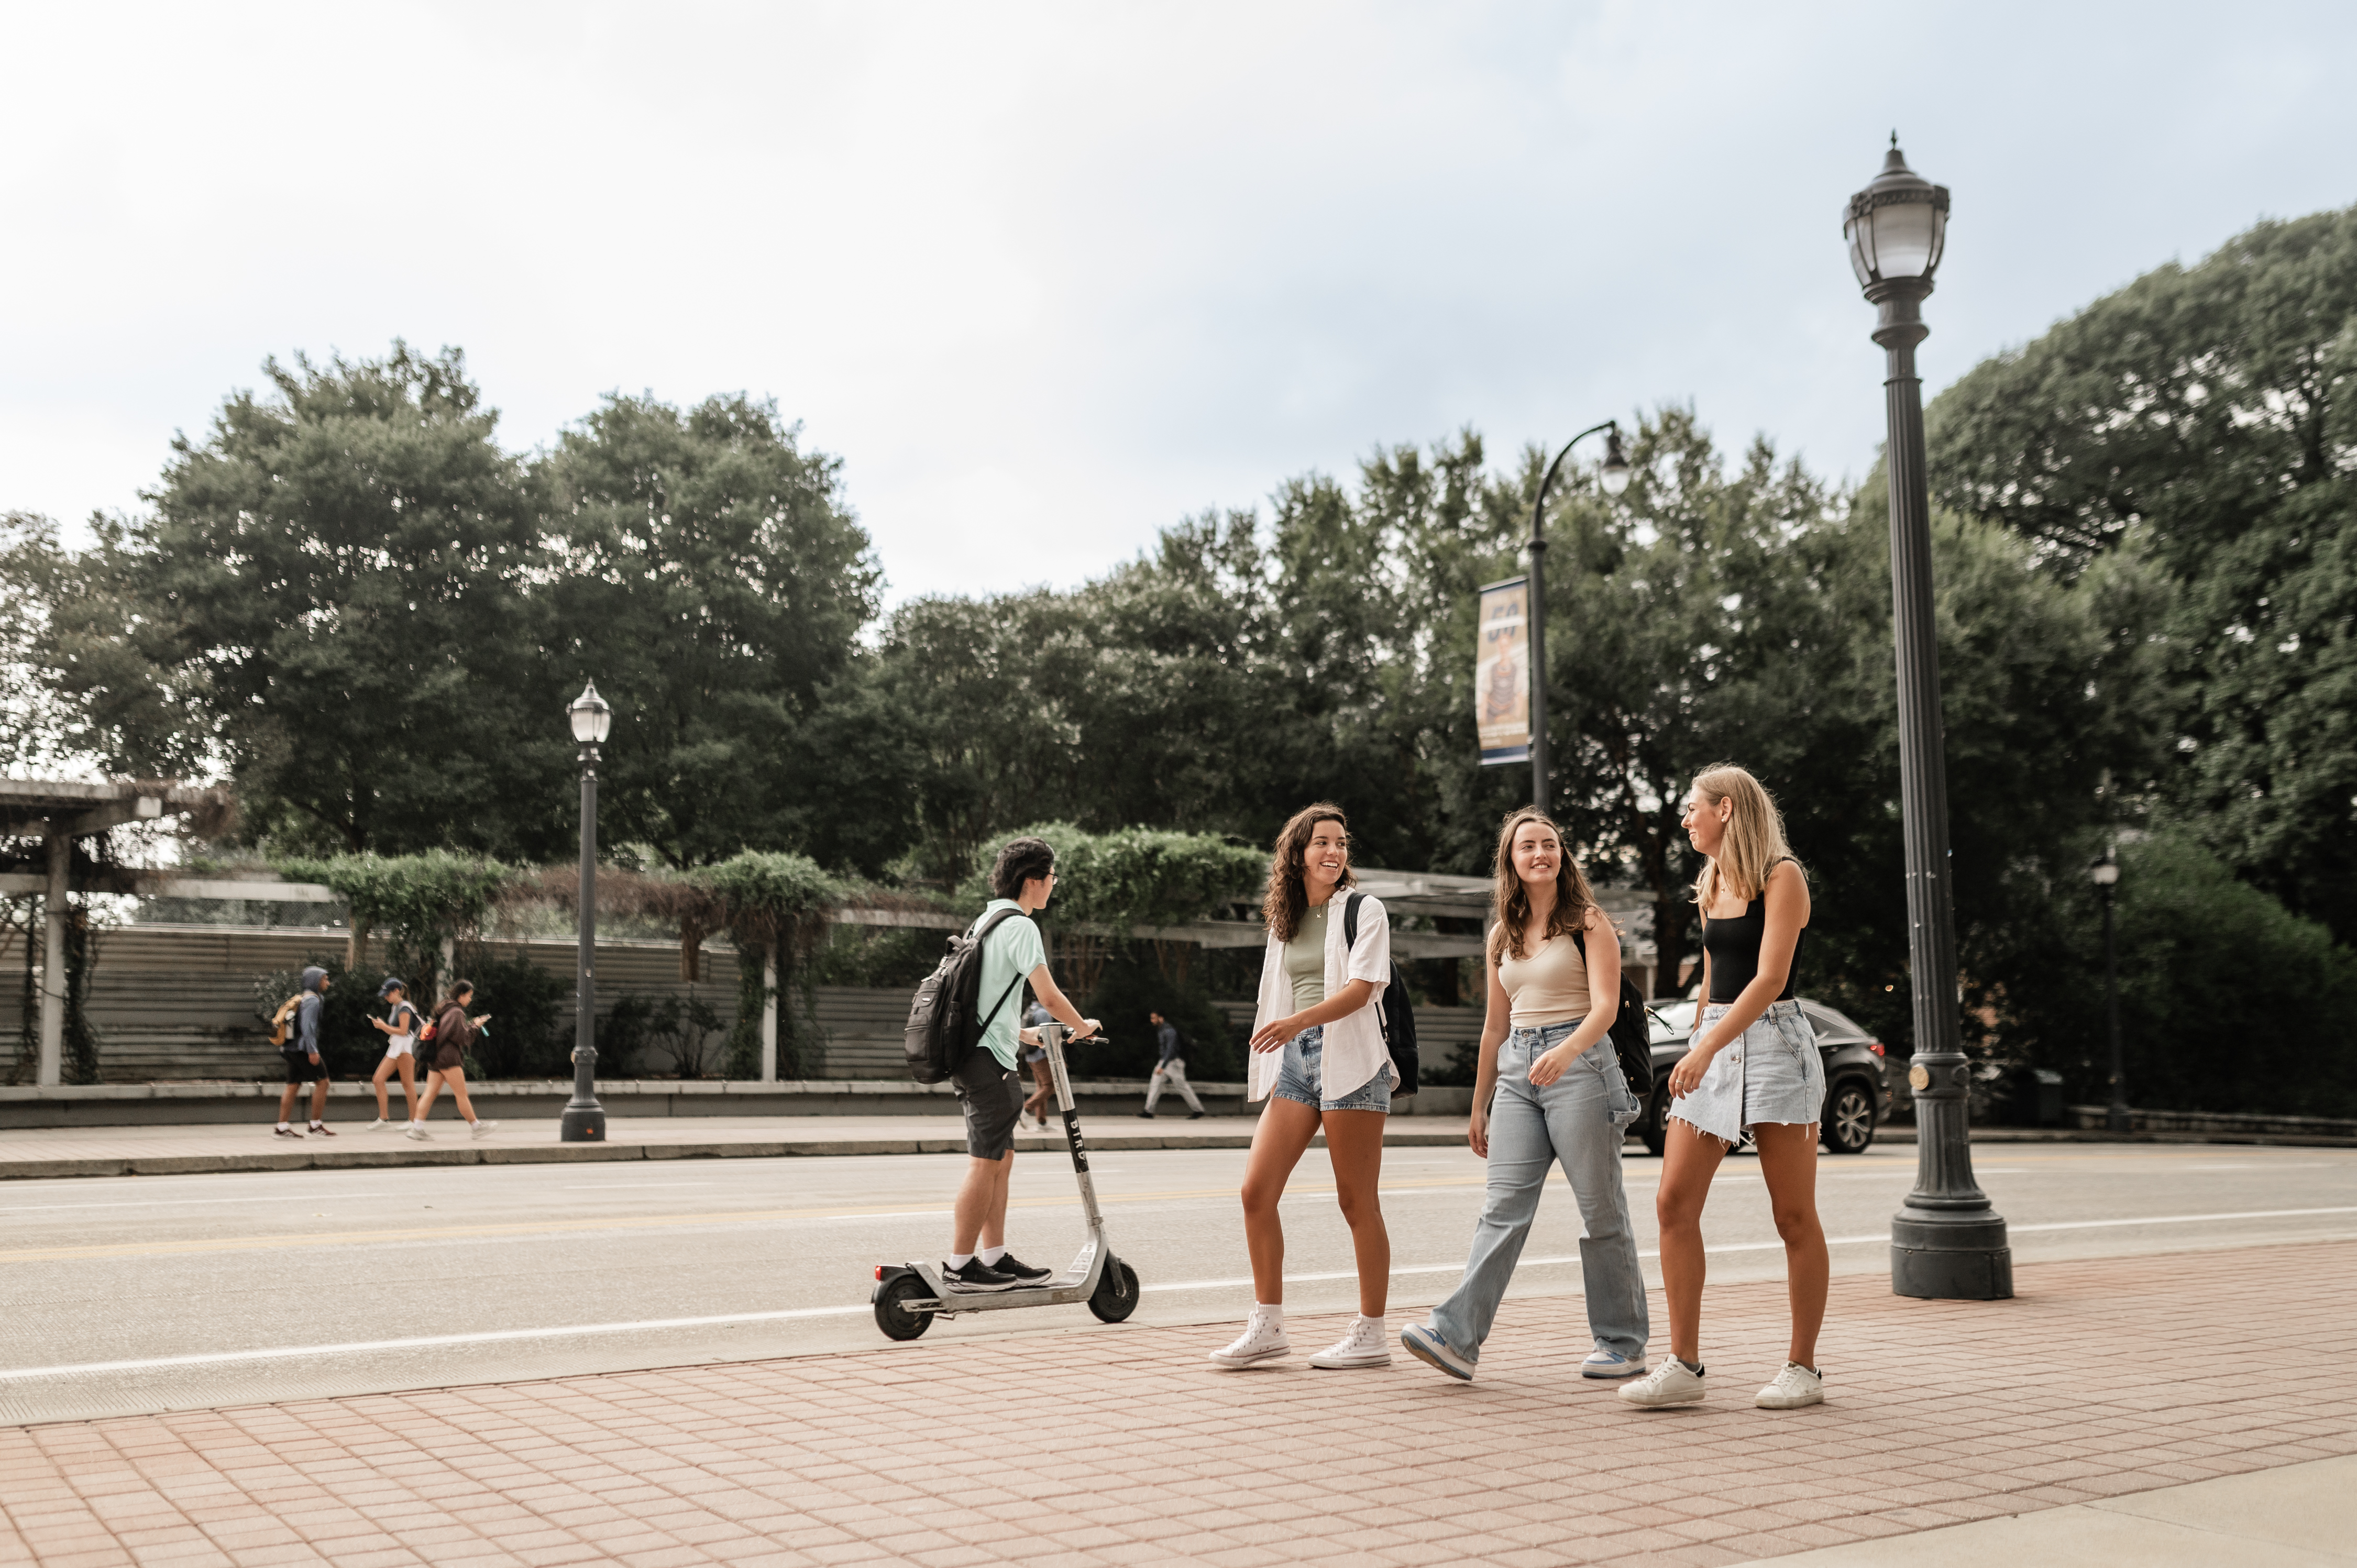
[1211,802,1398,1367]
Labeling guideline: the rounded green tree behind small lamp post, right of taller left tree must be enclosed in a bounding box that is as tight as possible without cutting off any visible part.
[537,394,891,868]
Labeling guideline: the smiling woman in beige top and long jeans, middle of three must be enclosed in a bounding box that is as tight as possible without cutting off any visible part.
[1400,807,1653,1379]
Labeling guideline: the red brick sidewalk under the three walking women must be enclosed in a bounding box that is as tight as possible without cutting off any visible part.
[0,1243,2357,1568]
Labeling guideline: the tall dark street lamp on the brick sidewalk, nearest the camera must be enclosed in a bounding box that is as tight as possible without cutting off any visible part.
[1841,132,2013,1301]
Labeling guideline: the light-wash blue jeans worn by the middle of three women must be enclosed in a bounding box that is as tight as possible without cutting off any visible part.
[1431,1021,1653,1361]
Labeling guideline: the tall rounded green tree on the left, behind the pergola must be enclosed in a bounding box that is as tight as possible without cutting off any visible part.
[52,344,568,854]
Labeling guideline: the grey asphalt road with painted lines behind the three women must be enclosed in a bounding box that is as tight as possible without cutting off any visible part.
[0,1144,2357,1422]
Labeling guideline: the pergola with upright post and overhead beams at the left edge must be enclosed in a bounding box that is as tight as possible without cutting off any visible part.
[0,778,250,1085]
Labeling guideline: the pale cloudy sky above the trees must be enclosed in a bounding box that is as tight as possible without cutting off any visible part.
[0,0,2357,601]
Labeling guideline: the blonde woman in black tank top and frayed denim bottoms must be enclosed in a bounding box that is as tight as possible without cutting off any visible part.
[1622,764,1829,1410]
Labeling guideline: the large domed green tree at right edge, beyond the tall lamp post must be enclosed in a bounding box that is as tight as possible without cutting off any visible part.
[1926,207,2357,941]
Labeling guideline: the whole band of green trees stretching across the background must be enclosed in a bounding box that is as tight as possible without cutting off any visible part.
[0,212,2357,1108]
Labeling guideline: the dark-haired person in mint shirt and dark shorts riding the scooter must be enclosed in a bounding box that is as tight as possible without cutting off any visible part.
[943,837,1098,1290]
